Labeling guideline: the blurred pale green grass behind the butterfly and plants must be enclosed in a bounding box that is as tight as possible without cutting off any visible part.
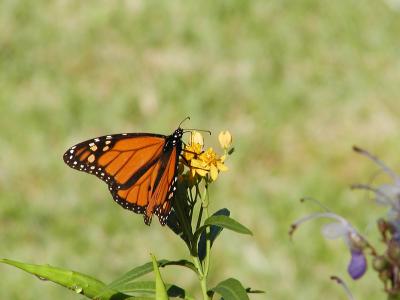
[0,0,400,300]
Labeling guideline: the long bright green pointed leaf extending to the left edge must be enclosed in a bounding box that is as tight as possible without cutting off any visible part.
[0,259,129,300]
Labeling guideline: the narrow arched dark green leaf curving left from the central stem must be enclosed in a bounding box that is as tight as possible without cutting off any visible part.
[107,259,197,290]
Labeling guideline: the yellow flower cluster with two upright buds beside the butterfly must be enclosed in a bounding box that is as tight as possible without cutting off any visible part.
[183,131,232,181]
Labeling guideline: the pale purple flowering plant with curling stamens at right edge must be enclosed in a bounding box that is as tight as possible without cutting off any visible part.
[289,147,400,300]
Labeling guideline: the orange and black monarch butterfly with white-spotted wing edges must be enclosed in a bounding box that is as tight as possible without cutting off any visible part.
[63,122,188,226]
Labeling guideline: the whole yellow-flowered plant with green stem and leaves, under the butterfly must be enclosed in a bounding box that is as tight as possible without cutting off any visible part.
[0,131,262,300]
